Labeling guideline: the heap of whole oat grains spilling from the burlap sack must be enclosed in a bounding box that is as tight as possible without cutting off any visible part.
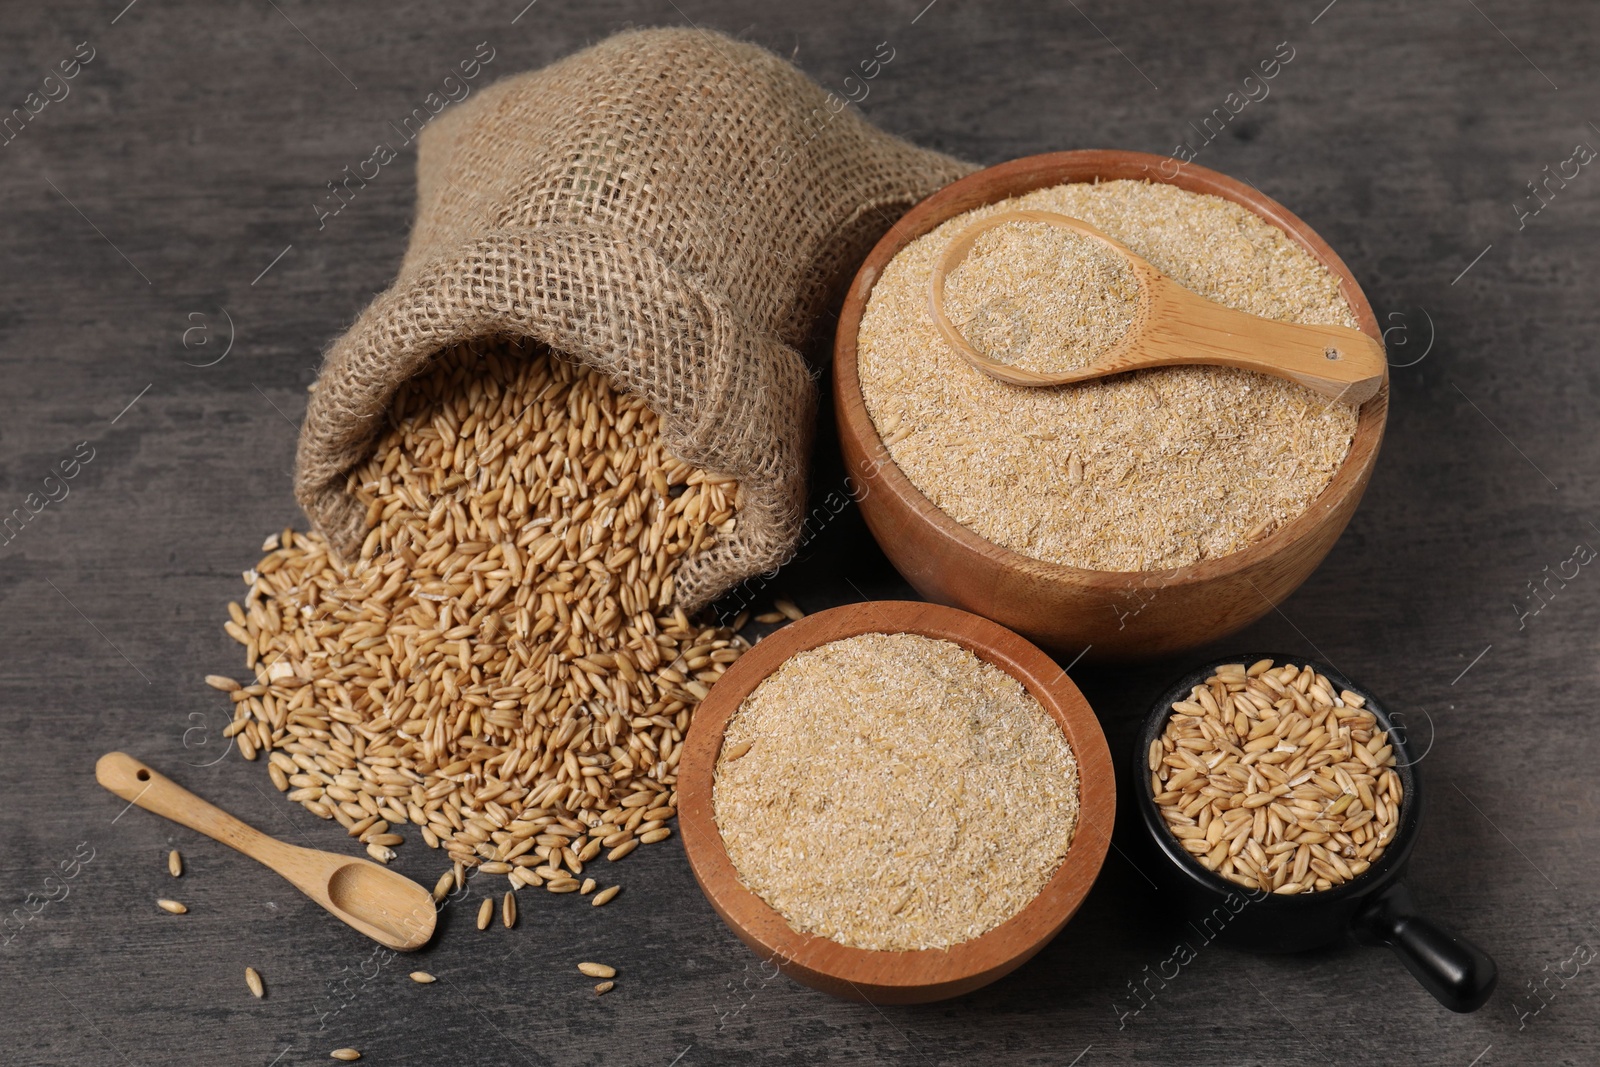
[210,342,744,896]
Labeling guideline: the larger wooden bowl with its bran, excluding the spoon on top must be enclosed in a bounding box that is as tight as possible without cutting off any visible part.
[834,150,1389,659]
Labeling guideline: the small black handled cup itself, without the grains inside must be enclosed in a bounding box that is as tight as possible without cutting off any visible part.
[1131,653,1498,1011]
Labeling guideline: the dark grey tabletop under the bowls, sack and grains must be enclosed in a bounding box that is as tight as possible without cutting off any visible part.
[0,0,1600,1067]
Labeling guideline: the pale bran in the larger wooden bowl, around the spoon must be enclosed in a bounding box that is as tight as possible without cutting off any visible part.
[858,181,1357,571]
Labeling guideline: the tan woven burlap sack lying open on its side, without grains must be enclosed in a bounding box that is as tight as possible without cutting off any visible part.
[294,29,971,609]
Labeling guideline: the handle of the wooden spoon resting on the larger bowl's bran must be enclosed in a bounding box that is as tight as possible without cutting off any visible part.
[1130,274,1387,405]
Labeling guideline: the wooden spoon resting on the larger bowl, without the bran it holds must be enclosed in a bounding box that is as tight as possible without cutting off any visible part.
[928,211,1387,405]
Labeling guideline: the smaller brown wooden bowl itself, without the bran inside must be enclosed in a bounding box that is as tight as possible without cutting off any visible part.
[678,600,1117,1005]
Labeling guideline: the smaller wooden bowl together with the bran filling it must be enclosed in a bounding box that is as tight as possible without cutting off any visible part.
[678,601,1115,1003]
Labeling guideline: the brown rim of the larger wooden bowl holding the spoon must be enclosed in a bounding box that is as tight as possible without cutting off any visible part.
[834,149,1389,593]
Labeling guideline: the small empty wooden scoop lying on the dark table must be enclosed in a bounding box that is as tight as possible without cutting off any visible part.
[94,752,437,952]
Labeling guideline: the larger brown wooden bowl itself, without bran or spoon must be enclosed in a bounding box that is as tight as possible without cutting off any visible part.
[834,150,1389,661]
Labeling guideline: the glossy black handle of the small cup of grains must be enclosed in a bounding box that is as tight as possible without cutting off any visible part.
[1354,883,1499,1011]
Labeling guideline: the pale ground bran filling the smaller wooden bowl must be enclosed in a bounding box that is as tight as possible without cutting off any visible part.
[712,633,1078,950]
